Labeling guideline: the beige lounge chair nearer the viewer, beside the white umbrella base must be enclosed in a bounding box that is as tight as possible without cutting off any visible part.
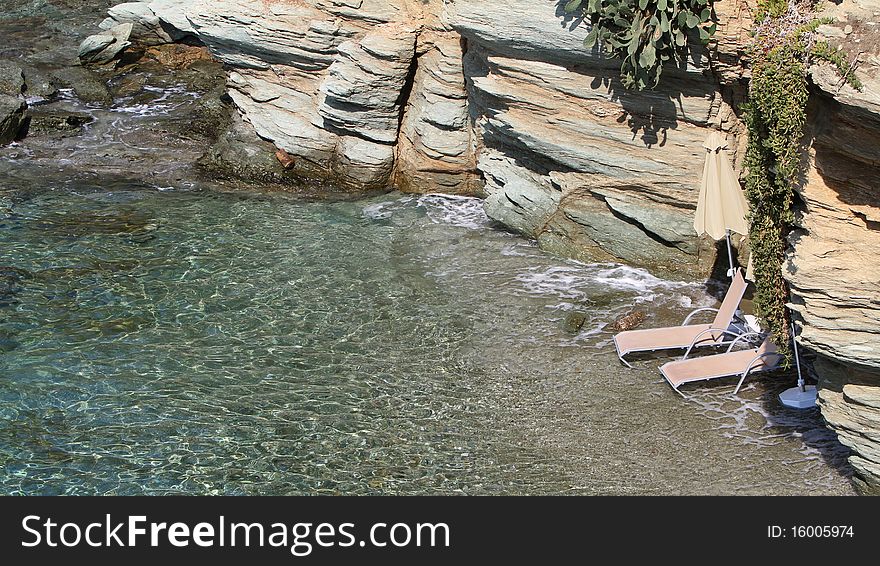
[660,333,782,395]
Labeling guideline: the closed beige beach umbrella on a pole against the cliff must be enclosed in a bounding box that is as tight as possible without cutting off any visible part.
[694,132,749,273]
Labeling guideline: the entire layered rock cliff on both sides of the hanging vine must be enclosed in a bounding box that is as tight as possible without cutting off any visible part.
[91,0,880,490]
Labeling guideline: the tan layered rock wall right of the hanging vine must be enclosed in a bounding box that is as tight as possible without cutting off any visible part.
[786,0,880,493]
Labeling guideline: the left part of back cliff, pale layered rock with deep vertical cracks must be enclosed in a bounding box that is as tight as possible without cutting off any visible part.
[103,0,479,193]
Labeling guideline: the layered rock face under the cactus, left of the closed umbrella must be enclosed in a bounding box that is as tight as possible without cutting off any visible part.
[444,0,721,272]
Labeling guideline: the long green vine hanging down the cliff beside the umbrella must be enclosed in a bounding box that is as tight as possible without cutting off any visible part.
[744,0,861,359]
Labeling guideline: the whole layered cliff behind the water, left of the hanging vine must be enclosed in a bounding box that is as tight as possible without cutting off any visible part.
[96,0,731,275]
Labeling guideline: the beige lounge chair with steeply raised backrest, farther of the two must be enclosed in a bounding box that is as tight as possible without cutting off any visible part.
[614,269,748,367]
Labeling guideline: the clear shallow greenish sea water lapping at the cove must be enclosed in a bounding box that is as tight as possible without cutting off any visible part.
[0,189,851,494]
